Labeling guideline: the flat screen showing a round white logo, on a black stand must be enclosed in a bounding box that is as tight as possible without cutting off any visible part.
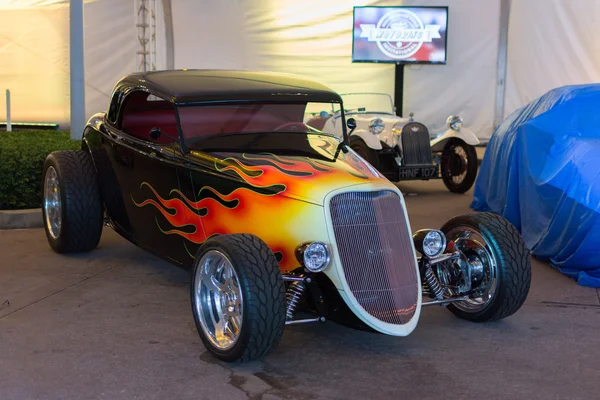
[352,7,448,64]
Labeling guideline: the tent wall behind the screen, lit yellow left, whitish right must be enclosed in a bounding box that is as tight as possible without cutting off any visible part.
[173,0,500,138]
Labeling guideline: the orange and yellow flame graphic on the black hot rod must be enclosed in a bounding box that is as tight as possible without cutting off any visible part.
[132,141,380,271]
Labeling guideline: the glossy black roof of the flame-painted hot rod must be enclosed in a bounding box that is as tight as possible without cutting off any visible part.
[117,69,341,104]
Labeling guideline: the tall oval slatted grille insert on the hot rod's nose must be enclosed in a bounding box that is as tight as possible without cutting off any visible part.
[330,190,420,324]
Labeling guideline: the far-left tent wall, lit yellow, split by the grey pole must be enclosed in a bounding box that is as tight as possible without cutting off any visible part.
[0,0,137,128]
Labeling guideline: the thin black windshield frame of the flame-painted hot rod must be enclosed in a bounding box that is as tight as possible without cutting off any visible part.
[173,99,348,153]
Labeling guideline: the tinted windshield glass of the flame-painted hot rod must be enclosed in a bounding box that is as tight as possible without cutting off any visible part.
[178,102,339,144]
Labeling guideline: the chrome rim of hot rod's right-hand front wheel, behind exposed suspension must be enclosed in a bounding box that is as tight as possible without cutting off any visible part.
[446,226,498,313]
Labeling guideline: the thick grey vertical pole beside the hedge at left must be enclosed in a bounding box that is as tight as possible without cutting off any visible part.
[69,0,85,140]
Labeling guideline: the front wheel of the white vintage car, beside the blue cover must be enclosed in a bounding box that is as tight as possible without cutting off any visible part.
[441,139,477,193]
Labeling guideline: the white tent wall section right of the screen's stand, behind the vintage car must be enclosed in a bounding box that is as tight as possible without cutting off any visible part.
[403,0,500,140]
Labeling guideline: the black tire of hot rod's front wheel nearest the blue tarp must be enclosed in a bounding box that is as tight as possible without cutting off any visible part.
[442,213,531,322]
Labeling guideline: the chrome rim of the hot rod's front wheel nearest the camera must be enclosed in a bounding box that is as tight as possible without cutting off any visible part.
[194,250,243,350]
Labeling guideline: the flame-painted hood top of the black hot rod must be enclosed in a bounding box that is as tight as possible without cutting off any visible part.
[190,133,389,205]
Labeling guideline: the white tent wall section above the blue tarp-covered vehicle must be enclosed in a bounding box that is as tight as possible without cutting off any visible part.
[504,0,600,116]
